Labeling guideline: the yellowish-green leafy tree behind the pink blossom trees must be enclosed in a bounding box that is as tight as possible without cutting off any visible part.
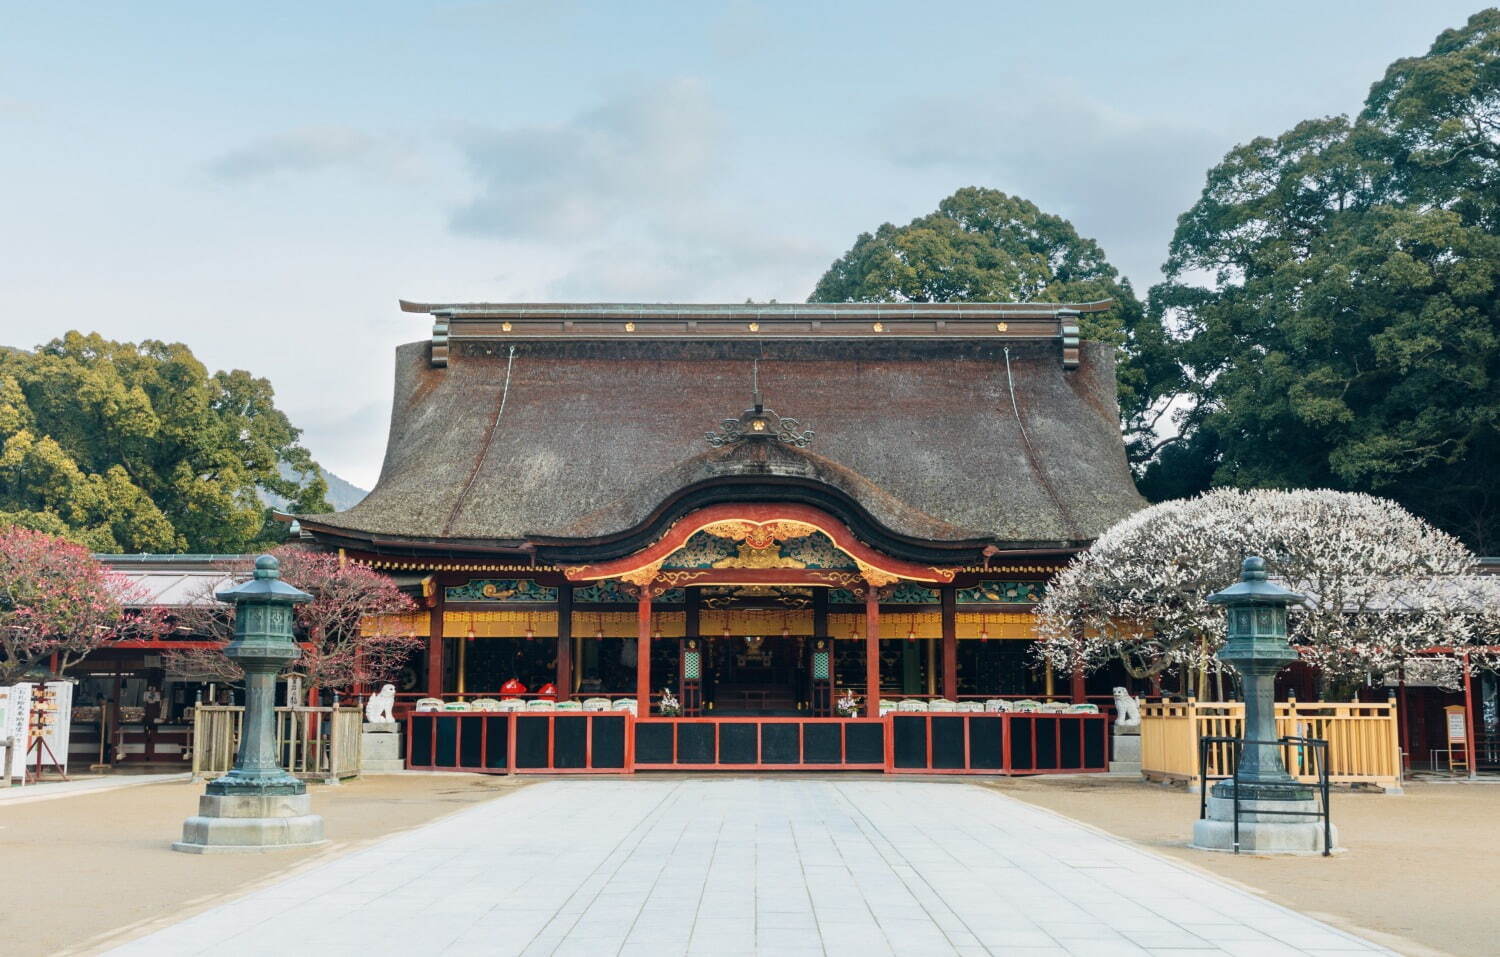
[0,332,327,552]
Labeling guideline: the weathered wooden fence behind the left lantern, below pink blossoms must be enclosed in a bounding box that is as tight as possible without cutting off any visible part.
[192,705,365,783]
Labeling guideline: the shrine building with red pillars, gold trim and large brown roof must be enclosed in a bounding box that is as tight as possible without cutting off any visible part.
[296,302,1143,750]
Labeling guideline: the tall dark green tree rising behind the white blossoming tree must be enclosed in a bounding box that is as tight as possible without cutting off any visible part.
[1142,9,1500,552]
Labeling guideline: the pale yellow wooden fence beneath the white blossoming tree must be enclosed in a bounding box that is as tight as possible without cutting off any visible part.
[1140,698,1401,789]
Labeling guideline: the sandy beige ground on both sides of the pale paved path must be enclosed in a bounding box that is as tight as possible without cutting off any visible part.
[0,774,1500,957]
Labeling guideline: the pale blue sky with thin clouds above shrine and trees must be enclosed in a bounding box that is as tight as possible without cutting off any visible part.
[0,0,1479,488]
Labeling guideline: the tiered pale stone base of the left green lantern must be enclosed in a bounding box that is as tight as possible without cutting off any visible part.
[173,791,329,854]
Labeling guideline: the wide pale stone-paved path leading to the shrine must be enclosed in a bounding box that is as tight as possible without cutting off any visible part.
[114,777,1388,957]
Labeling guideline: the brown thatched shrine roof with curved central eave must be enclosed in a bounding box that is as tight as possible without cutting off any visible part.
[299,306,1143,567]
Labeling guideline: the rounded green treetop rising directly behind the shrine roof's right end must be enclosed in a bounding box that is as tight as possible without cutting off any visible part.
[809,186,1178,456]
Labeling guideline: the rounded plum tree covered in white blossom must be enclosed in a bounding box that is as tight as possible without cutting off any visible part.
[1037,489,1496,693]
